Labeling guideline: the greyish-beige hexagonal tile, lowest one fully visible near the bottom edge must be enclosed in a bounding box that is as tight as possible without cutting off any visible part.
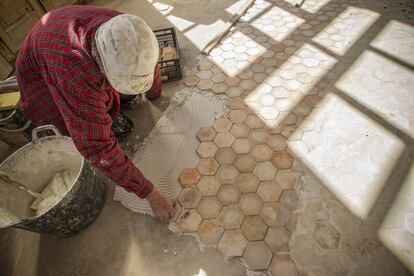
[243,241,274,270]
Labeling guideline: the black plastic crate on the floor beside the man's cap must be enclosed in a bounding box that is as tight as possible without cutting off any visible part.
[154,28,182,82]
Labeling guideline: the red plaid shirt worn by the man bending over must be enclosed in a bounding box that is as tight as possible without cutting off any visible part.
[16,6,153,197]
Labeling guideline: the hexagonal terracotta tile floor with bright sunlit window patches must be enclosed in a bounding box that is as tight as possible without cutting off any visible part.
[172,0,414,275]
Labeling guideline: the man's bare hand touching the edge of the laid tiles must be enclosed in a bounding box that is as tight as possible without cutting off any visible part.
[145,186,175,221]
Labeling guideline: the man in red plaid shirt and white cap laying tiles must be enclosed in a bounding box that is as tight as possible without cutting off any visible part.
[16,5,175,221]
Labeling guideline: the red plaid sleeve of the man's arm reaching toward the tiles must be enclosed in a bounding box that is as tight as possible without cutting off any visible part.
[53,58,153,198]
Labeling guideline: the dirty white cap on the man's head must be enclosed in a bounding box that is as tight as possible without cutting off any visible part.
[95,14,159,95]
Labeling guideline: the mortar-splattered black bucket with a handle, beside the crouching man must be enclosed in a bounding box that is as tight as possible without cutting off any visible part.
[0,126,106,236]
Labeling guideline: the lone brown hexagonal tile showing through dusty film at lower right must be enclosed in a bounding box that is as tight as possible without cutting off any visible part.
[313,221,341,249]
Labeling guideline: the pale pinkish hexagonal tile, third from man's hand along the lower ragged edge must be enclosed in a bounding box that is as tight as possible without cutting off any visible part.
[219,230,247,257]
